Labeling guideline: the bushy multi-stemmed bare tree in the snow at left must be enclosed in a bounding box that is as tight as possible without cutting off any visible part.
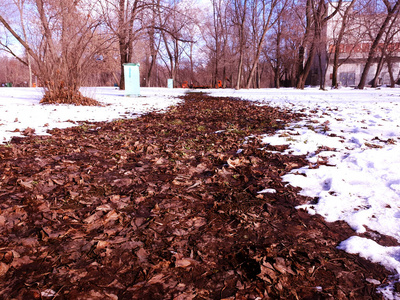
[0,0,111,104]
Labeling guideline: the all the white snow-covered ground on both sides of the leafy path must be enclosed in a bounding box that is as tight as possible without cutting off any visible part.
[0,88,400,299]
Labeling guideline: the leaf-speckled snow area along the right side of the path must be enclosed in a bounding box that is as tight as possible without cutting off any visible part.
[208,88,400,299]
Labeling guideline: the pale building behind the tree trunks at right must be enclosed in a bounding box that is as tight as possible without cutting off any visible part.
[309,2,400,86]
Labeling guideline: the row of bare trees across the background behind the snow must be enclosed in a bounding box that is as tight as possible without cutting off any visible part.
[0,0,400,102]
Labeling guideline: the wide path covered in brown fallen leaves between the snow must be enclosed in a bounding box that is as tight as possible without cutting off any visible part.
[0,94,390,299]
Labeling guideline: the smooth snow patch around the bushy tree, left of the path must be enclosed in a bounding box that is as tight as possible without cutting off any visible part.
[0,87,184,143]
